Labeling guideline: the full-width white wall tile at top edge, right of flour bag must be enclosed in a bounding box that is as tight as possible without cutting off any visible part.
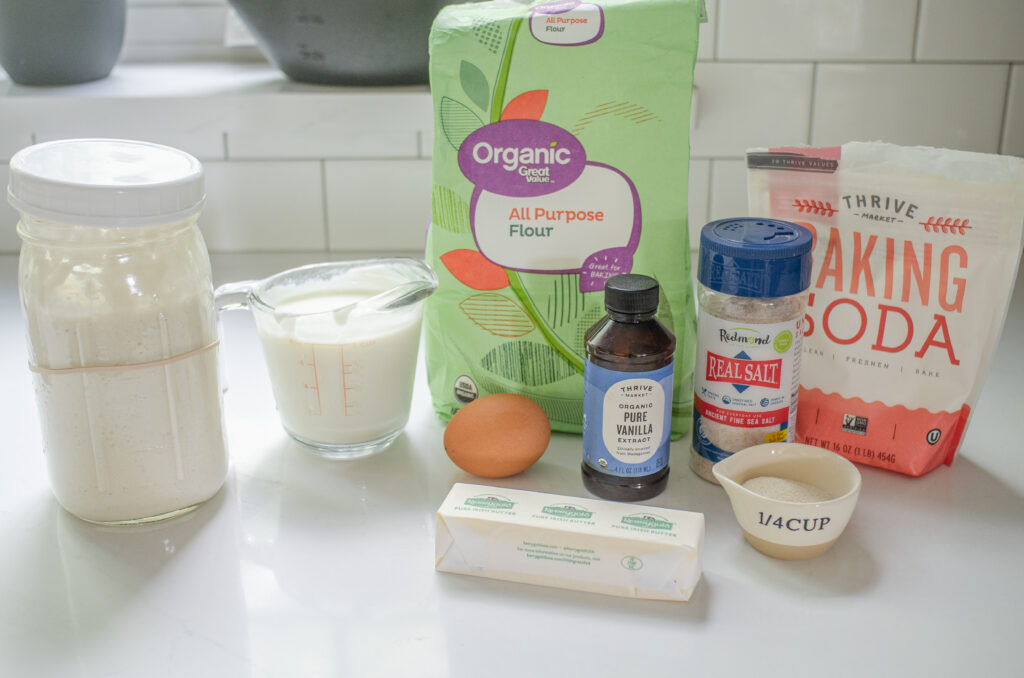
[718,0,918,61]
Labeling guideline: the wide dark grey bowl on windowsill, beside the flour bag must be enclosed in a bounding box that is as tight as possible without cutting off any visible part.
[229,0,453,85]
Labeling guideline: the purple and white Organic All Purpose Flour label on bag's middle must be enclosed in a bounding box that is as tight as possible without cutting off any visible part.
[459,120,641,284]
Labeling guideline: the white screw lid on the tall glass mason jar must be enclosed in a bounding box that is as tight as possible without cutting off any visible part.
[7,139,206,227]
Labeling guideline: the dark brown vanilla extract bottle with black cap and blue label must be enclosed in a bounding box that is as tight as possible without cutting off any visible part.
[582,274,676,502]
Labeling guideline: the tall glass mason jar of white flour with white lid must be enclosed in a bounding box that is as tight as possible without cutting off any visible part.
[9,139,227,523]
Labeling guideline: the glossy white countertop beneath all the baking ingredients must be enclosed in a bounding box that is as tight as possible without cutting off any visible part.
[0,254,1024,678]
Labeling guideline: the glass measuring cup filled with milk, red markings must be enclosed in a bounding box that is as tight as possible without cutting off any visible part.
[215,257,437,459]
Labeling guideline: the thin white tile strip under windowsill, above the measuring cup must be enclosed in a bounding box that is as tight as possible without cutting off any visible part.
[227,130,419,160]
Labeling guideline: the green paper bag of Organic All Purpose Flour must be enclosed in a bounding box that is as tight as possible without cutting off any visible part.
[424,0,706,437]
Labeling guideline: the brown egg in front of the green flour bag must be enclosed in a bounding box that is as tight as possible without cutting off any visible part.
[444,393,551,478]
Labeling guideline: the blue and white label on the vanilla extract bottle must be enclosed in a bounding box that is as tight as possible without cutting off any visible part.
[583,361,673,477]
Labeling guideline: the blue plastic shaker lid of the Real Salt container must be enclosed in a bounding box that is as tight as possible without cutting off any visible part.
[697,217,813,298]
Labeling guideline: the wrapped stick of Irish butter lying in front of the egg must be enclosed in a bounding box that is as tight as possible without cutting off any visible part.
[434,482,705,600]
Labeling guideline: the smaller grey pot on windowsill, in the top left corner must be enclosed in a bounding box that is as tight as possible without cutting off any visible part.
[0,0,125,85]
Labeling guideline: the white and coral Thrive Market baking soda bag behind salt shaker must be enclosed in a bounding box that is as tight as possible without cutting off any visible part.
[748,142,1024,475]
